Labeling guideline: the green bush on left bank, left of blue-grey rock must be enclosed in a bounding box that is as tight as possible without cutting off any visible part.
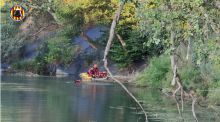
[13,36,76,75]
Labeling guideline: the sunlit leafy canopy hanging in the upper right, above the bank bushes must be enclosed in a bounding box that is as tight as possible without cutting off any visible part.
[137,0,220,62]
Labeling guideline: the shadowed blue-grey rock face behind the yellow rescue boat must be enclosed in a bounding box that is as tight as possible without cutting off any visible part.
[57,26,106,77]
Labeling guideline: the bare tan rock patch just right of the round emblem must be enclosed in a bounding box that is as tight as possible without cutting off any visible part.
[19,9,59,40]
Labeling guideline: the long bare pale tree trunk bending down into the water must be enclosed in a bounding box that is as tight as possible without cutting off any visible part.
[103,2,148,122]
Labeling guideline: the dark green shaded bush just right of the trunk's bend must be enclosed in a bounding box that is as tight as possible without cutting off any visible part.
[110,30,162,67]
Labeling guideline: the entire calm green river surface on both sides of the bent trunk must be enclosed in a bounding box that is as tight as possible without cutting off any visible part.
[1,76,220,122]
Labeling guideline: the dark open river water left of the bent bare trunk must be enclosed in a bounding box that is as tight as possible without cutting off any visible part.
[1,76,141,122]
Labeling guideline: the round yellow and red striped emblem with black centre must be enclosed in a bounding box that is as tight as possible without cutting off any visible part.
[10,5,25,21]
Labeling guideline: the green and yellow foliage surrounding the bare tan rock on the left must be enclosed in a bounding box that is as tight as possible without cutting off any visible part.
[1,0,118,74]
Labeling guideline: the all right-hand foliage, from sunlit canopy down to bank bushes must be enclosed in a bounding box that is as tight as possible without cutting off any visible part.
[137,0,220,97]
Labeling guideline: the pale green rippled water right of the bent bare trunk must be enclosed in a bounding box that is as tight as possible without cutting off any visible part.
[130,87,220,122]
